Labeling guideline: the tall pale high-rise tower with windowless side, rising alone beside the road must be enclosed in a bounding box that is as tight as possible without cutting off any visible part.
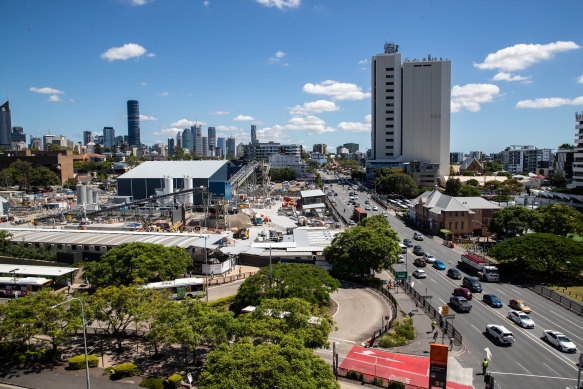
[367,43,451,176]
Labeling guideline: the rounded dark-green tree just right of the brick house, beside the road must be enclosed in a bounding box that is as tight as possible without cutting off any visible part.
[488,206,540,238]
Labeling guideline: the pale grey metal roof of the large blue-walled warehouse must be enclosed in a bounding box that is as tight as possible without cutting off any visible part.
[118,161,229,179]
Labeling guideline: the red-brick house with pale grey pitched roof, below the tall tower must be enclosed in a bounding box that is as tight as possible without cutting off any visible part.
[409,189,500,236]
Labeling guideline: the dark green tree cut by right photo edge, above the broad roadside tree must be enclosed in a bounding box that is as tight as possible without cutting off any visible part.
[534,203,583,236]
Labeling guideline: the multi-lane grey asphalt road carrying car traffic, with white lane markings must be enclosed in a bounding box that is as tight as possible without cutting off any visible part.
[328,172,583,388]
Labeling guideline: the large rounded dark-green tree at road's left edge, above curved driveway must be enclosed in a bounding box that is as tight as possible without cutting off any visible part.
[324,215,401,274]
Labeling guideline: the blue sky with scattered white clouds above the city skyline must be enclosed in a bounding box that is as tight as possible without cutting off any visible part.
[0,0,583,152]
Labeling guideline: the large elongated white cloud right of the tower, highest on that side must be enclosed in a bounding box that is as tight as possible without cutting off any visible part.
[474,41,580,71]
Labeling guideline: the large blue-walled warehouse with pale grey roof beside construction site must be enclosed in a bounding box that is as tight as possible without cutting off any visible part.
[117,161,237,203]
